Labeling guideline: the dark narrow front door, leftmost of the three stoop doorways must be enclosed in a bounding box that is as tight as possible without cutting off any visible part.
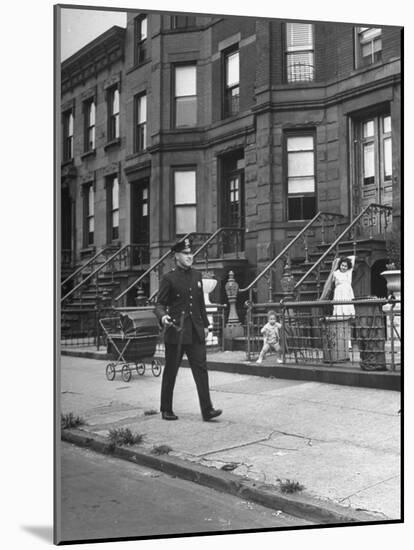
[131,178,150,265]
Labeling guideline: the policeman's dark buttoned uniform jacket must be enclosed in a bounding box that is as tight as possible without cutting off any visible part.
[155,267,209,344]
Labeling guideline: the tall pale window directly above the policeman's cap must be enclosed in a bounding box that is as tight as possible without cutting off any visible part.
[174,170,196,235]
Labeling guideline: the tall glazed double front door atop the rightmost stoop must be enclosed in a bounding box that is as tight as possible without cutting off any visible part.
[353,114,392,233]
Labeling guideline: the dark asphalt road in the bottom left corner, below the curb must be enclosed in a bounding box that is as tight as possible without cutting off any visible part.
[57,443,311,541]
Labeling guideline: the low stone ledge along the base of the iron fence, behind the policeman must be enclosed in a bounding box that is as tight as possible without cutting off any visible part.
[61,349,401,391]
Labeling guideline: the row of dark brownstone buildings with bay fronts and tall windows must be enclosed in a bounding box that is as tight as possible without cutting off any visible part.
[60,13,402,310]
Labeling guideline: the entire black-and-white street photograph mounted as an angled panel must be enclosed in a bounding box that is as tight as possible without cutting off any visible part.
[45,3,404,544]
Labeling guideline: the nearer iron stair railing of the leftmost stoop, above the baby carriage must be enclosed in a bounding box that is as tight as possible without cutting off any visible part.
[61,244,149,303]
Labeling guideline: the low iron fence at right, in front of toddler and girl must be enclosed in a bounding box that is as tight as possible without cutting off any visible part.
[245,298,401,371]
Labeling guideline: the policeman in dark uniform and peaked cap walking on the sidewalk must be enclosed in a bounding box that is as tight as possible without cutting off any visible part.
[155,238,222,421]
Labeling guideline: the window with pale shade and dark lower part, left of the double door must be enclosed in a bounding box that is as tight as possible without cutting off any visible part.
[286,135,316,220]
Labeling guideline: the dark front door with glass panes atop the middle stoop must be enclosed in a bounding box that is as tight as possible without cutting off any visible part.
[220,151,245,252]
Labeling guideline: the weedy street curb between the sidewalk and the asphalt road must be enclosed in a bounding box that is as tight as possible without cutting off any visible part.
[61,429,388,524]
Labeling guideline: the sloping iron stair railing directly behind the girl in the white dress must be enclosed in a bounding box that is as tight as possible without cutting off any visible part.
[293,203,392,299]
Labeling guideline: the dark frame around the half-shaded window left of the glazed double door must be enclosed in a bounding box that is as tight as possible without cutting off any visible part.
[284,129,318,223]
